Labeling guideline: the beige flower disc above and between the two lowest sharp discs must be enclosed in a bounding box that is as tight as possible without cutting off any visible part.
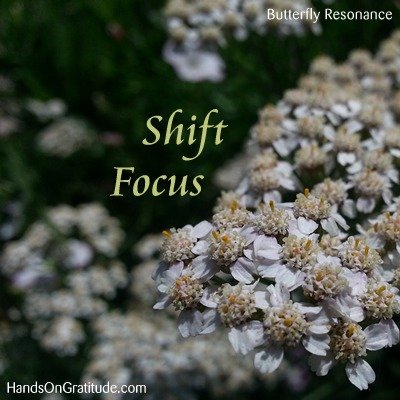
[303,263,347,301]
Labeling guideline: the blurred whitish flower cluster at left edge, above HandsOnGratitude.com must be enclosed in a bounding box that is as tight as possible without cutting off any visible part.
[1,203,128,355]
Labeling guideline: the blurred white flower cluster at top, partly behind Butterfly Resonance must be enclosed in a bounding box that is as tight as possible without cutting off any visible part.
[164,0,321,82]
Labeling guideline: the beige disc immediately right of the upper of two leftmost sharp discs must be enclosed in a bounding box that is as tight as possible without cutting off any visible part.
[209,229,246,267]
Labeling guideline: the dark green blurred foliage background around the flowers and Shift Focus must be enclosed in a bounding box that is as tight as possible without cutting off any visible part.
[0,0,400,400]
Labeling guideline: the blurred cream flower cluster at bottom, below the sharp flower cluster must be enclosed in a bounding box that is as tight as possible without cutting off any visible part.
[82,235,314,400]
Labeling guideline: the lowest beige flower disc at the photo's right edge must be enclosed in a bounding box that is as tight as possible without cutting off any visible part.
[360,279,400,319]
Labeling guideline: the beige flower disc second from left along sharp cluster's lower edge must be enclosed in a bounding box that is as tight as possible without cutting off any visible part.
[215,283,257,328]
